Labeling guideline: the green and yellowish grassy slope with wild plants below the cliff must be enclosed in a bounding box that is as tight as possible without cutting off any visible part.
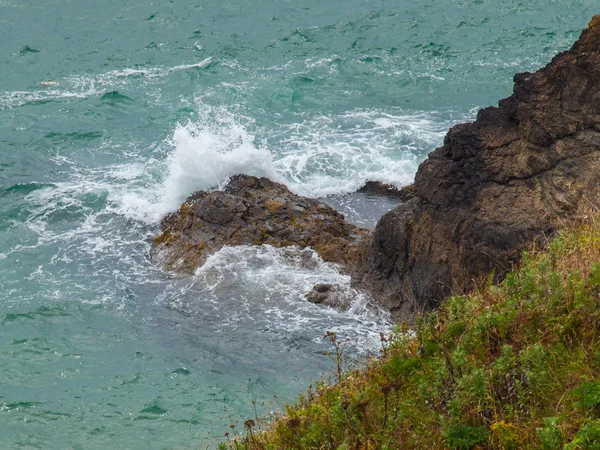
[221,219,600,450]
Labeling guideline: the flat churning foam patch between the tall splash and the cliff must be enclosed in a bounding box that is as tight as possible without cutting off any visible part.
[274,110,448,197]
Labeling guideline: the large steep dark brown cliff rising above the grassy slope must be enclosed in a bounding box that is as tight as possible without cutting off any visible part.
[363,16,600,318]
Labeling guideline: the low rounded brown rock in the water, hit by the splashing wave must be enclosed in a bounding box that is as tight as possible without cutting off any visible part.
[154,175,371,273]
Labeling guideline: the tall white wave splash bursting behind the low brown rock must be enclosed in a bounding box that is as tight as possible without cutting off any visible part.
[113,109,281,222]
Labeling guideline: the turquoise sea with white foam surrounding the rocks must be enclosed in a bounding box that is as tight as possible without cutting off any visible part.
[0,0,598,449]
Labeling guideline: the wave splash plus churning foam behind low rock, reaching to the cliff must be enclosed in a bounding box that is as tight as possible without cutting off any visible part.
[111,103,464,223]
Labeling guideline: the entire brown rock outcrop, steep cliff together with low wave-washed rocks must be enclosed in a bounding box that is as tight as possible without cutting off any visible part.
[155,16,600,320]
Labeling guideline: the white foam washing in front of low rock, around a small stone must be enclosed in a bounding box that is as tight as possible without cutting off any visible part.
[161,245,391,352]
